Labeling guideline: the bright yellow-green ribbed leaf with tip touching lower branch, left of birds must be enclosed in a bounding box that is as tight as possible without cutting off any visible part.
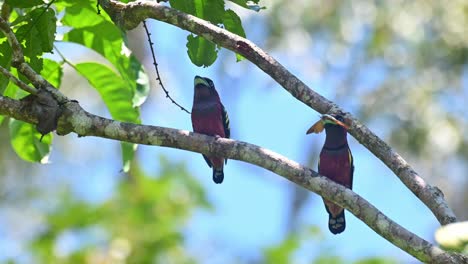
[75,62,140,123]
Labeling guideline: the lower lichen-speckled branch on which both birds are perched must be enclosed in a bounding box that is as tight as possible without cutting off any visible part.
[0,96,468,263]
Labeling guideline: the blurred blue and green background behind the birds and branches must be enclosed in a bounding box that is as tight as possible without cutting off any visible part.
[0,0,468,263]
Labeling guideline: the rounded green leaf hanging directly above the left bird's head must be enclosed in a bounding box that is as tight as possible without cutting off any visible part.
[187,35,218,67]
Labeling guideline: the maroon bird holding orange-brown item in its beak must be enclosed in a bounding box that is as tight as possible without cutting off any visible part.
[307,115,354,235]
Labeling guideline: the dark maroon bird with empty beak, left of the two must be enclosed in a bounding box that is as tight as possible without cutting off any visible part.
[191,76,231,184]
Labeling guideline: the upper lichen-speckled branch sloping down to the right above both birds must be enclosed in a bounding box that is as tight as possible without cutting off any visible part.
[100,0,456,225]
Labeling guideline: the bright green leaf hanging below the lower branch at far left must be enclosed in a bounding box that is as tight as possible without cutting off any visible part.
[9,118,52,163]
